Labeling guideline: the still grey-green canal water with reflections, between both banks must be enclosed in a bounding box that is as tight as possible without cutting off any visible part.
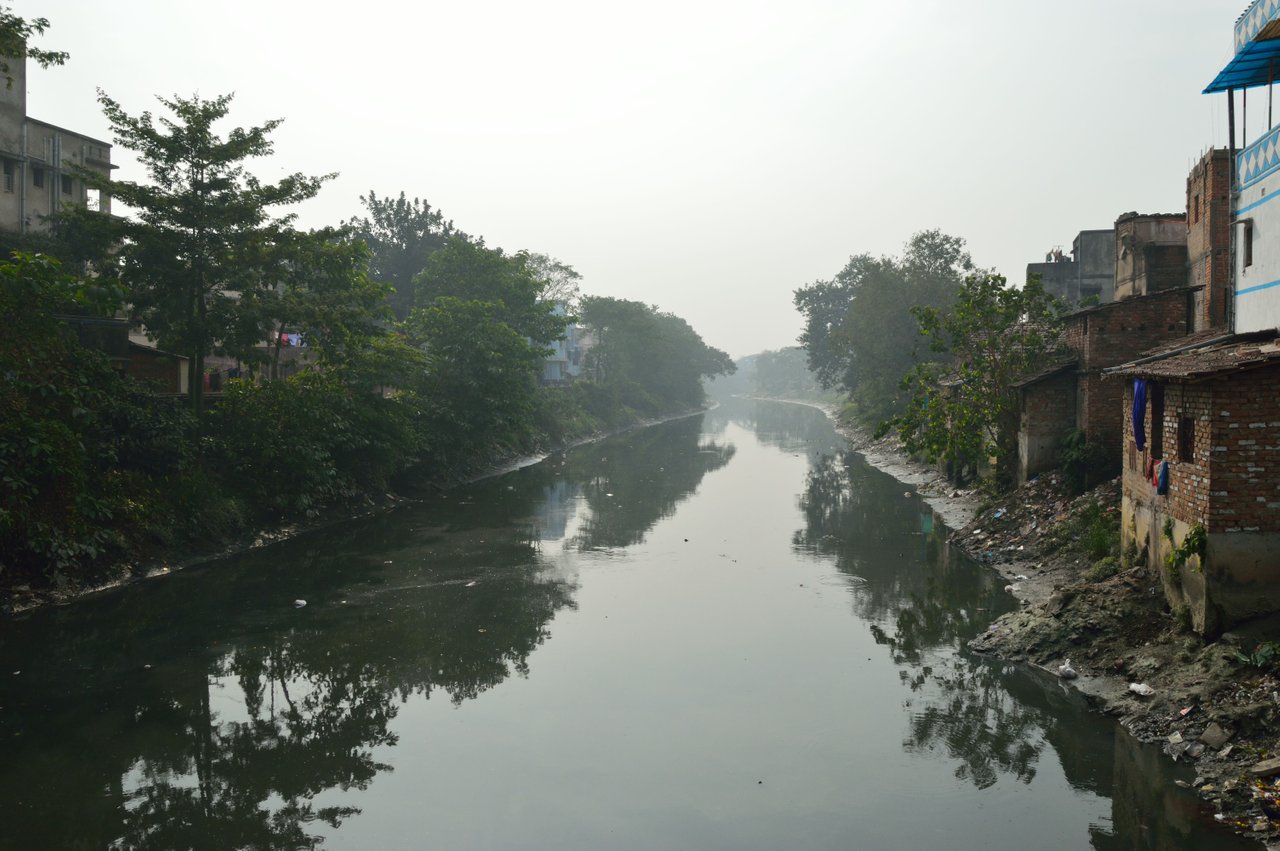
[0,401,1253,851]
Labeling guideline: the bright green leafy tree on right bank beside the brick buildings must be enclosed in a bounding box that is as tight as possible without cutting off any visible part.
[882,273,1062,489]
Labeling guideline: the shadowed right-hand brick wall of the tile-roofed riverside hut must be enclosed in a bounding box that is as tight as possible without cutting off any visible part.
[1208,366,1280,532]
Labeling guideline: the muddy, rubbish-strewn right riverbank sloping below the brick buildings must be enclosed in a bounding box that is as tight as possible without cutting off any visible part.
[828,411,1280,848]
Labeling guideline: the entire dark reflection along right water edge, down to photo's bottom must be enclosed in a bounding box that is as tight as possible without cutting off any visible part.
[792,435,1257,848]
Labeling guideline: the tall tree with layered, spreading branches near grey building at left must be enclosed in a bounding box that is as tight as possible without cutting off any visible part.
[82,91,334,415]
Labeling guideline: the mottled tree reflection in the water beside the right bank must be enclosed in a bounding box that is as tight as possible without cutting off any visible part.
[794,454,1052,788]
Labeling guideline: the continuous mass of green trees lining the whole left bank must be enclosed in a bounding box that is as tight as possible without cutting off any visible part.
[0,64,733,587]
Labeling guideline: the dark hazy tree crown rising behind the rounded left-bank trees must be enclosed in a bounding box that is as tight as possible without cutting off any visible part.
[347,189,455,319]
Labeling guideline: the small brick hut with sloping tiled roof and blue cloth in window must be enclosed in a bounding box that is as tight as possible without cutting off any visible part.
[1110,330,1280,635]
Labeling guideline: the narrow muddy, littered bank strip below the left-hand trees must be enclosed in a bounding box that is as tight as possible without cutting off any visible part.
[0,402,716,616]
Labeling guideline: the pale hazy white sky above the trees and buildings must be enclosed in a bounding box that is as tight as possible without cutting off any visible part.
[27,0,1249,357]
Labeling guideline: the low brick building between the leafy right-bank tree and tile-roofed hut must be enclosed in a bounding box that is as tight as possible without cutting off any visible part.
[1015,287,1199,482]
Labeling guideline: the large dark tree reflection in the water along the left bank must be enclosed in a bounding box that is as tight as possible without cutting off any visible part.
[0,409,733,850]
